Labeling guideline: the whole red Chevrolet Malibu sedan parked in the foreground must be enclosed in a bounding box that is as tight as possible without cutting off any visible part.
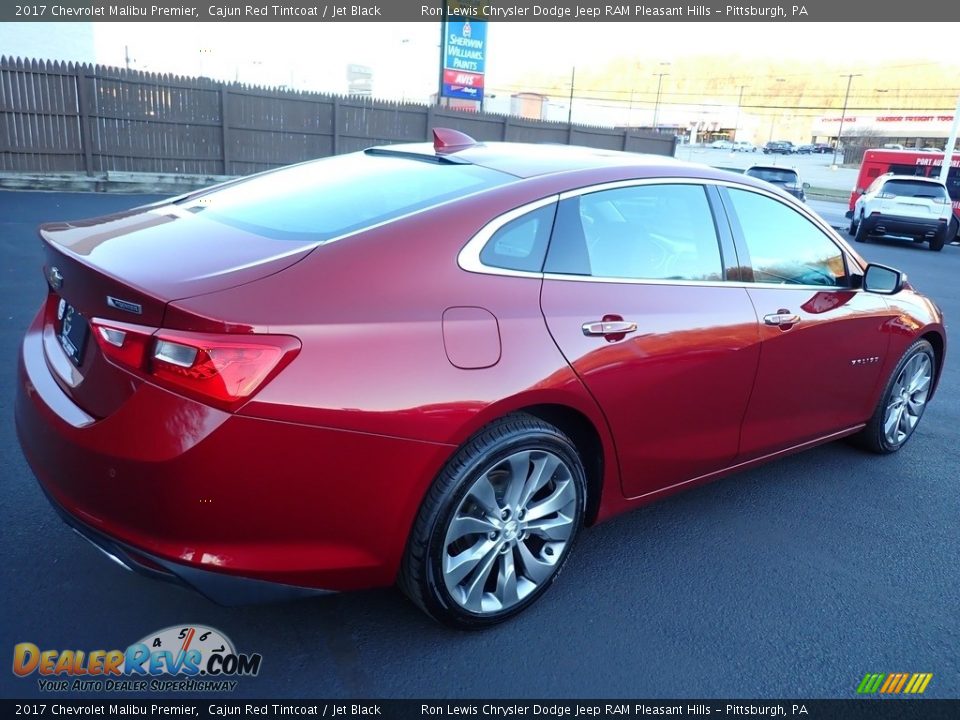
[16,130,946,628]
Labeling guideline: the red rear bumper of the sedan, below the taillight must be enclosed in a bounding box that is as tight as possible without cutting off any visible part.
[15,312,452,604]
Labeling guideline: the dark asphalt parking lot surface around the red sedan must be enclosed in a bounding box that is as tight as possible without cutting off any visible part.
[0,188,960,698]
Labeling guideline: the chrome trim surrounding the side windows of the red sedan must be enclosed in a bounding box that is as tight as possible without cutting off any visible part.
[457,177,864,284]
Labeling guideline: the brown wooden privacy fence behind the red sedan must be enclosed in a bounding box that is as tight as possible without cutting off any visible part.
[0,57,675,175]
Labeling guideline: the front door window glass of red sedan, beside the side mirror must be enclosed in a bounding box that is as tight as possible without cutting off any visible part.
[729,188,848,287]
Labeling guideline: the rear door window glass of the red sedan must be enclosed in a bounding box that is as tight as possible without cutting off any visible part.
[544,184,723,281]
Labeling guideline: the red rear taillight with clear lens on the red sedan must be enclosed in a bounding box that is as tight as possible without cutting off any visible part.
[90,318,300,410]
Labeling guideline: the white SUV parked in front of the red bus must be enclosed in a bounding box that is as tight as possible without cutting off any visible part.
[849,174,953,250]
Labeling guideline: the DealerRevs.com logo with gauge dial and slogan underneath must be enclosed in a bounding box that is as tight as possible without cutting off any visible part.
[13,625,263,692]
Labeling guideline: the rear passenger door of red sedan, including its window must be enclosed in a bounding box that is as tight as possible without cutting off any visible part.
[541,180,759,497]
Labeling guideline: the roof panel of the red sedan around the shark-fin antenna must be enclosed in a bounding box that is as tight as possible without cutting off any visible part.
[368,142,703,178]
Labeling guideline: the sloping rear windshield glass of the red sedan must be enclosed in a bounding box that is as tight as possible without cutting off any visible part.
[183,152,516,241]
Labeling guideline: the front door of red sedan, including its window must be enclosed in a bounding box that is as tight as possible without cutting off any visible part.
[721,187,893,459]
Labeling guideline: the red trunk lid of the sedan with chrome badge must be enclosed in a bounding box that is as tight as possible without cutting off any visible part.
[40,205,316,418]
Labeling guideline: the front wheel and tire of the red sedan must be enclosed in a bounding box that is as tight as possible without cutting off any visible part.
[855,340,937,455]
